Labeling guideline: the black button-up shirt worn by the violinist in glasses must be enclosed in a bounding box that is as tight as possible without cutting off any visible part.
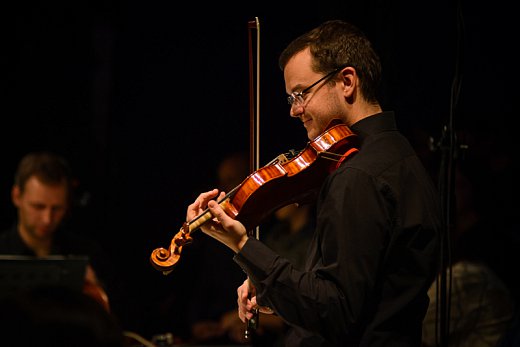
[234,112,443,347]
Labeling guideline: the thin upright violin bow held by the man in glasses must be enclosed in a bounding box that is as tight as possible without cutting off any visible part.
[244,17,260,340]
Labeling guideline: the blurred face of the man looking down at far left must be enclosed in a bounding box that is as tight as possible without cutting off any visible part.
[11,176,68,241]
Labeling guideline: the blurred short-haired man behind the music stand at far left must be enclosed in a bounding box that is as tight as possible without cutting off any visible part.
[0,152,115,310]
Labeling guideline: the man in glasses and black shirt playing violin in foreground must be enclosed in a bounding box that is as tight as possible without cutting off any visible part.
[187,21,443,347]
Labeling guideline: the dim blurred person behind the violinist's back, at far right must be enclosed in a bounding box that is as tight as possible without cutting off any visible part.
[423,168,515,347]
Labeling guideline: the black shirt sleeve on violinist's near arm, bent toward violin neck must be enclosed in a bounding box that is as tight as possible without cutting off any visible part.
[234,170,389,337]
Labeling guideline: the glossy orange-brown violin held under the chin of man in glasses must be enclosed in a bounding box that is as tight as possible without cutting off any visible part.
[150,120,358,275]
